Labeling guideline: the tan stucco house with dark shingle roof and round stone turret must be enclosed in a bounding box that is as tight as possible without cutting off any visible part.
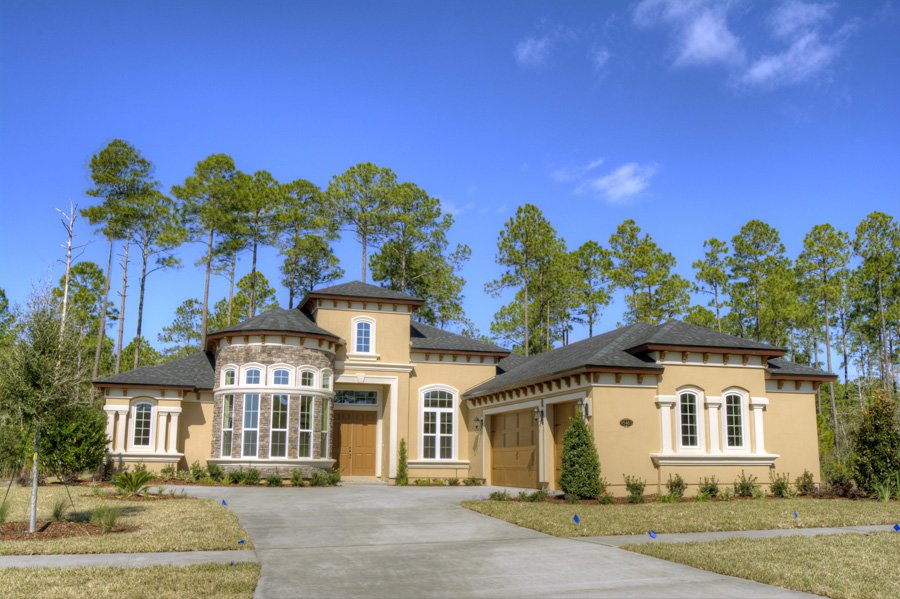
[94,281,834,494]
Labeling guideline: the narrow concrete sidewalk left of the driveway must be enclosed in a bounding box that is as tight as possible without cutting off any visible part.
[0,550,259,568]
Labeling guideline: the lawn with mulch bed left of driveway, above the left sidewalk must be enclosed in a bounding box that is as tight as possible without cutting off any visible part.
[0,486,252,556]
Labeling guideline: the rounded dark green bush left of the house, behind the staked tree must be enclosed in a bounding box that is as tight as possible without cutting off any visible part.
[40,406,108,482]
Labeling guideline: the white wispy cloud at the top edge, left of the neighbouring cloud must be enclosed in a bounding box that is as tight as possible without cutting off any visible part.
[634,0,745,66]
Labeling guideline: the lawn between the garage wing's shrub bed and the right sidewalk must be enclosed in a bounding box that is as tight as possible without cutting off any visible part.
[463,498,900,537]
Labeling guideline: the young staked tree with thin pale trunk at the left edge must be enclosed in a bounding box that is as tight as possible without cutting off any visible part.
[0,291,87,533]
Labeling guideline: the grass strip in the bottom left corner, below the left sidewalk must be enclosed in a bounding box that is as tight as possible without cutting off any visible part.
[0,563,259,599]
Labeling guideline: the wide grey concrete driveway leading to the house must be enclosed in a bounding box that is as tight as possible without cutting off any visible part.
[189,484,804,599]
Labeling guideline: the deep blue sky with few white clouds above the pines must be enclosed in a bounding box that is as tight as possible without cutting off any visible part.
[0,0,900,352]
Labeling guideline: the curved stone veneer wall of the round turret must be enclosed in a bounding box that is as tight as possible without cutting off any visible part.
[211,343,334,476]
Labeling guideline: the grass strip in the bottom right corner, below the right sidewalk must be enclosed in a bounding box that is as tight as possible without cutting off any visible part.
[625,536,900,599]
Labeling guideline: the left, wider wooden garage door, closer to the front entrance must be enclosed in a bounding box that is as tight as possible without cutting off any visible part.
[491,410,538,489]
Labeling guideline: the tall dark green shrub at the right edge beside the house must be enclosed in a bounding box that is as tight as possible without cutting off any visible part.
[852,392,900,493]
